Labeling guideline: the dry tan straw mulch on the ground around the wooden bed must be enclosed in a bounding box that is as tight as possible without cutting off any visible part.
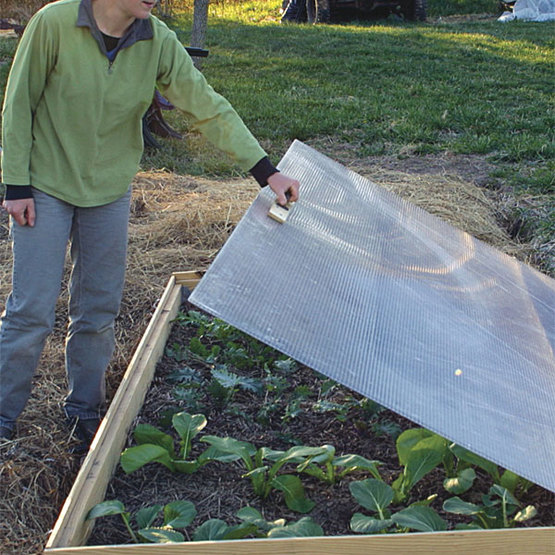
[0,165,527,554]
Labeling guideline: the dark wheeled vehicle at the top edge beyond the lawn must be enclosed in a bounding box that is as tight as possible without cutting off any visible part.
[281,0,428,23]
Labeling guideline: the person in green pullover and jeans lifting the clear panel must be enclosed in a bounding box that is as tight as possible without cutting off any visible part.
[0,0,299,448]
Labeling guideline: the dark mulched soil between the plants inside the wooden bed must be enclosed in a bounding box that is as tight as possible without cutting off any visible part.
[88,302,555,545]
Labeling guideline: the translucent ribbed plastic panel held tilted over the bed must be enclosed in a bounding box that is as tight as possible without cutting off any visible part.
[190,141,555,491]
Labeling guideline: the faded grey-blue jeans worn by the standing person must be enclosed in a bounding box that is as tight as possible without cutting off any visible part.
[0,189,131,429]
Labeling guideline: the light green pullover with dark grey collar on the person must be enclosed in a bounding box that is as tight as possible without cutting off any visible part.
[2,0,266,207]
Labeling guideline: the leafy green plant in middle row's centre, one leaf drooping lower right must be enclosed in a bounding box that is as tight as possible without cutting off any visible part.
[201,436,325,513]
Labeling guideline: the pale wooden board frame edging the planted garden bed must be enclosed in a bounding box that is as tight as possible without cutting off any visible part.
[45,271,555,555]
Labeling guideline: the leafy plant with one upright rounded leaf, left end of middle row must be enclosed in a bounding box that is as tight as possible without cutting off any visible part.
[120,412,229,474]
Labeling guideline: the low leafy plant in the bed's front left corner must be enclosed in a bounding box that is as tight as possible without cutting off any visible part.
[86,499,197,543]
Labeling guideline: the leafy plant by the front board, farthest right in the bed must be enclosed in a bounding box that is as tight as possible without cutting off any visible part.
[443,484,537,529]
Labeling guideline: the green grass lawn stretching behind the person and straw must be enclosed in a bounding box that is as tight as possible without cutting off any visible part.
[0,0,555,270]
